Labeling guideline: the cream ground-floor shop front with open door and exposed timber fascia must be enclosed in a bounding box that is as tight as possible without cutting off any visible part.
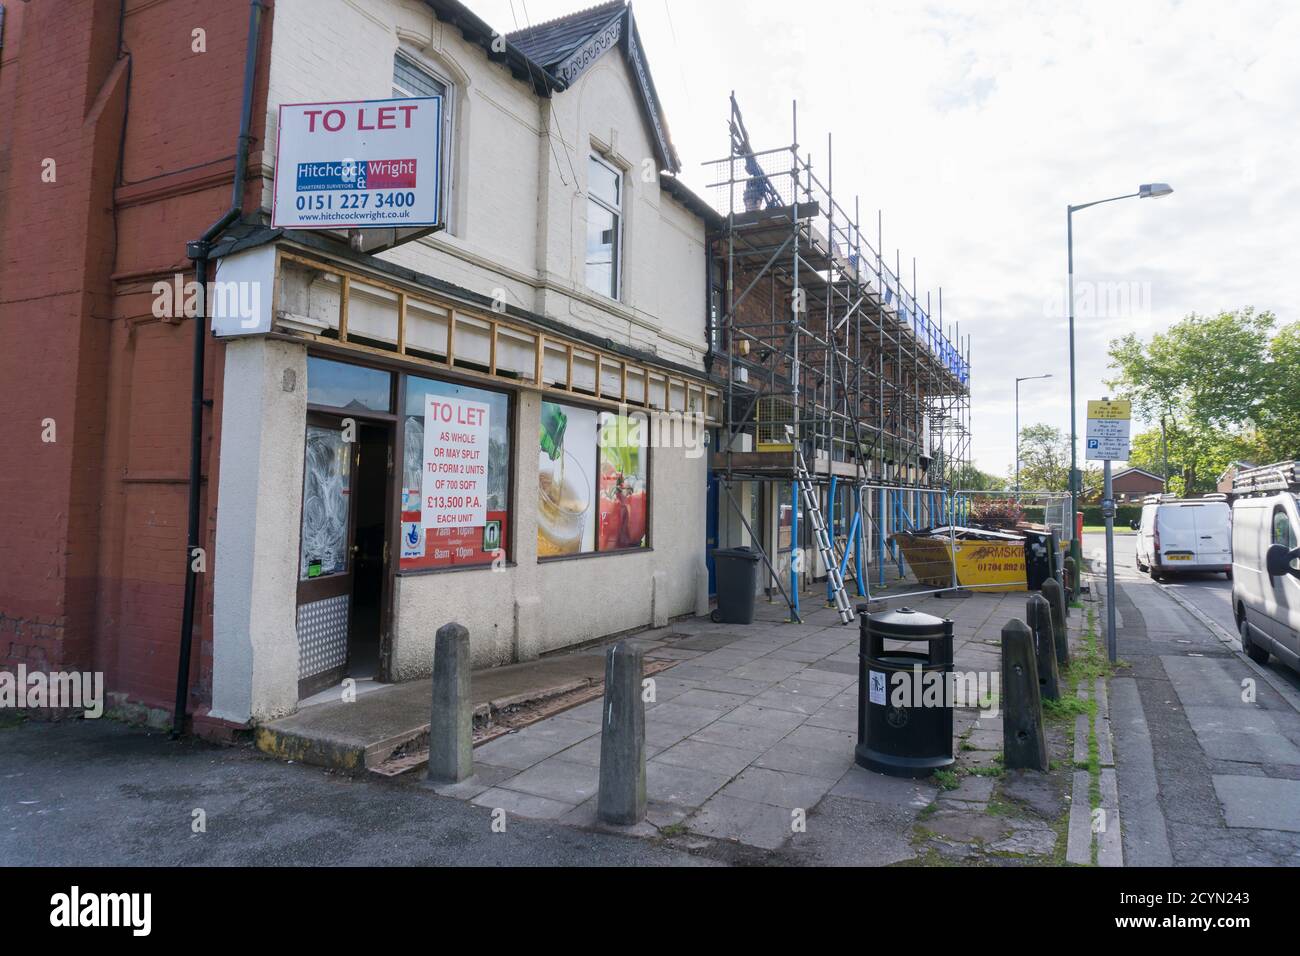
[213,245,718,722]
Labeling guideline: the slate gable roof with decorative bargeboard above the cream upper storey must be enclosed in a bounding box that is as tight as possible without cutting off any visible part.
[504,0,681,173]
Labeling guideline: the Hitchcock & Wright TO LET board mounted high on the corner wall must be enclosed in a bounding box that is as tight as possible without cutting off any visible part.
[272,96,442,229]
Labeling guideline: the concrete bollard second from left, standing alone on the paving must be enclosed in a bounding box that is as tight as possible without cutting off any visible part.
[595,641,646,826]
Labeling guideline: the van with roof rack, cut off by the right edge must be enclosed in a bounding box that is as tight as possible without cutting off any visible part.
[1232,462,1300,670]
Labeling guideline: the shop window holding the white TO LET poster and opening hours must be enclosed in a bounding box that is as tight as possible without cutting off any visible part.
[398,376,511,571]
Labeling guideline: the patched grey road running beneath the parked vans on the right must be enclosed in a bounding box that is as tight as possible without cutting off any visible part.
[1083,535,1300,866]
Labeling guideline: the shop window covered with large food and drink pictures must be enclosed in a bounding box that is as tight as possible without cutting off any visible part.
[537,402,650,558]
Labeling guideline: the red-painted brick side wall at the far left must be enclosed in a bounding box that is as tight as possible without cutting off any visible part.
[0,0,272,709]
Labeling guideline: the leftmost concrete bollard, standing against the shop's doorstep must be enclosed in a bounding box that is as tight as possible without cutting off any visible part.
[425,622,475,784]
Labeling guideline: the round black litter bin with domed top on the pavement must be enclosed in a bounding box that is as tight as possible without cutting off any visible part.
[853,605,953,777]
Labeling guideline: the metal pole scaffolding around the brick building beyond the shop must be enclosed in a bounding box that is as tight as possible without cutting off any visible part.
[705,95,971,620]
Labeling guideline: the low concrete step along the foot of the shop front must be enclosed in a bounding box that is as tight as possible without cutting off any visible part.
[256,631,667,774]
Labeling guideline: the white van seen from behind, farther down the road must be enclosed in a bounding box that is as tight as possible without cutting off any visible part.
[1131,494,1232,580]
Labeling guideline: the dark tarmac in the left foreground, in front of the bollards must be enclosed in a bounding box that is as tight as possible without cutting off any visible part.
[0,719,711,866]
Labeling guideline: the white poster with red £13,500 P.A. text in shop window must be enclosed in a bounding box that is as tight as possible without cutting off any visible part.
[420,395,490,528]
